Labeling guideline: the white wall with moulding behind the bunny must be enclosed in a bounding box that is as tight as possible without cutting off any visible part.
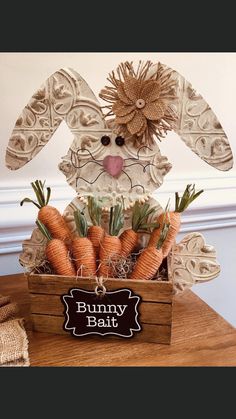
[0,53,236,325]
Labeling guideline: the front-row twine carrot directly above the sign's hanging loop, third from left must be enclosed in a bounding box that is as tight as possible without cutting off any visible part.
[99,204,124,277]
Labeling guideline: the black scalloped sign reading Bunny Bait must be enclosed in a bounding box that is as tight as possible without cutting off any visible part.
[62,288,141,338]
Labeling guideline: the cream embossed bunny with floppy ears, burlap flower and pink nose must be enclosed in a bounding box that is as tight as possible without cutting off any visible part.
[6,62,233,290]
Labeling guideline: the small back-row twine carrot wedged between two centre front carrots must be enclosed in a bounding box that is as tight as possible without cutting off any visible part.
[88,196,105,258]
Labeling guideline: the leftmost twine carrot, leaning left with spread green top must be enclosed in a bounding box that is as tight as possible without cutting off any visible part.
[20,180,72,245]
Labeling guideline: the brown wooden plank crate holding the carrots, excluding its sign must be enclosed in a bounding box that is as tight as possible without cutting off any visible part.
[28,274,173,344]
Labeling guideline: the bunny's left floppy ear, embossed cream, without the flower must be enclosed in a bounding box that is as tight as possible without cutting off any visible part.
[6,68,106,170]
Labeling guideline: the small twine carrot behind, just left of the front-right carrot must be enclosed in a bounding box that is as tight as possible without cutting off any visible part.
[120,201,159,258]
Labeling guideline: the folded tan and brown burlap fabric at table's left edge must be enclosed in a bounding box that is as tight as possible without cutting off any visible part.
[0,296,30,367]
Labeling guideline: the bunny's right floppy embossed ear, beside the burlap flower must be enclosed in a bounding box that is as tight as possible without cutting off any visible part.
[163,65,233,171]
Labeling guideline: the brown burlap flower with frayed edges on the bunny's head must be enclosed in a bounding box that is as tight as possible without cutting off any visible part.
[100,61,177,145]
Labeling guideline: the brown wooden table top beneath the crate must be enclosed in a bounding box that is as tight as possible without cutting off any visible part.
[0,274,236,366]
